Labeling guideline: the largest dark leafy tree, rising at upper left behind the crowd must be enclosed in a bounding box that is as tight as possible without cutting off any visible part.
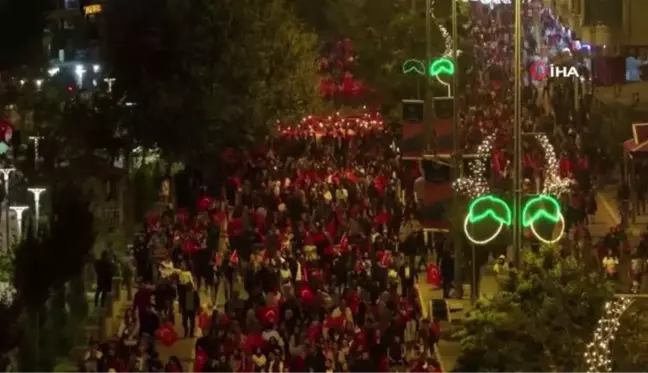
[103,0,319,164]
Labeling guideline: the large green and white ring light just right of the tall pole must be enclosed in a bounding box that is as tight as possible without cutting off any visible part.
[522,194,565,244]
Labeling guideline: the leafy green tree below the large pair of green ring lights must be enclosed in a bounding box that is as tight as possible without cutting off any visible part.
[458,246,612,373]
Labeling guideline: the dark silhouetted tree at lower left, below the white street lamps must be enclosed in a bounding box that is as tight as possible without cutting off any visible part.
[0,187,95,364]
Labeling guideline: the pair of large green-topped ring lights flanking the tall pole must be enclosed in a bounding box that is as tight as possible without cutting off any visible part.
[464,194,565,245]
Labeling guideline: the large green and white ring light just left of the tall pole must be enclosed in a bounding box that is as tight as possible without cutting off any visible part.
[464,195,513,245]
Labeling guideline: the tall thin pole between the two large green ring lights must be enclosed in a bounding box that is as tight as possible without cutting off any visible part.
[513,1,522,268]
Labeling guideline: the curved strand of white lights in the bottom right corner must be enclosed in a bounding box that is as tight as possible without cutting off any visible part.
[584,297,634,373]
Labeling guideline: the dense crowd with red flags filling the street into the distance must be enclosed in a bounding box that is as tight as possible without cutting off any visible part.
[74,2,612,373]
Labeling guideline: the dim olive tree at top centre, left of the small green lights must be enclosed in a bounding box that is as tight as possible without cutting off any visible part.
[292,0,445,104]
